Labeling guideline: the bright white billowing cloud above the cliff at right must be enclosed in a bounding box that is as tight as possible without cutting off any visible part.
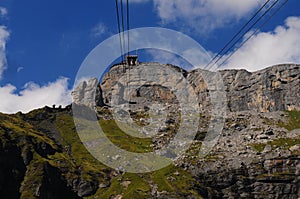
[226,17,300,71]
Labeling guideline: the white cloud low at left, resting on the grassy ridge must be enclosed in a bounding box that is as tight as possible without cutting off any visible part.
[0,77,71,113]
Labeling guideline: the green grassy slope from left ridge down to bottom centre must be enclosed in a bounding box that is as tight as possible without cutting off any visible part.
[0,109,201,198]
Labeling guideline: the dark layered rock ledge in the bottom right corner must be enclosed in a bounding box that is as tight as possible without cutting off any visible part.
[193,157,300,199]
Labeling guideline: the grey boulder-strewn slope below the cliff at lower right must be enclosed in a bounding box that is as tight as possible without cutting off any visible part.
[188,111,300,199]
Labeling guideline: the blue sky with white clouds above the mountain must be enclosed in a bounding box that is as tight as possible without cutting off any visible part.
[0,0,300,113]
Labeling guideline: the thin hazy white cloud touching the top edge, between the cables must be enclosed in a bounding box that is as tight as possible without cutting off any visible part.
[153,0,264,33]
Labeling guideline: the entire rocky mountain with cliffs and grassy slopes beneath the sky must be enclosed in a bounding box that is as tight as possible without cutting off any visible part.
[0,63,300,199]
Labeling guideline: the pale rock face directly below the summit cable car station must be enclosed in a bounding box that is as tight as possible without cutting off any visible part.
[101,63,184,105]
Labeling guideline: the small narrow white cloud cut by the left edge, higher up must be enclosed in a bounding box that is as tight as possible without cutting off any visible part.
[0,26,9,79]
